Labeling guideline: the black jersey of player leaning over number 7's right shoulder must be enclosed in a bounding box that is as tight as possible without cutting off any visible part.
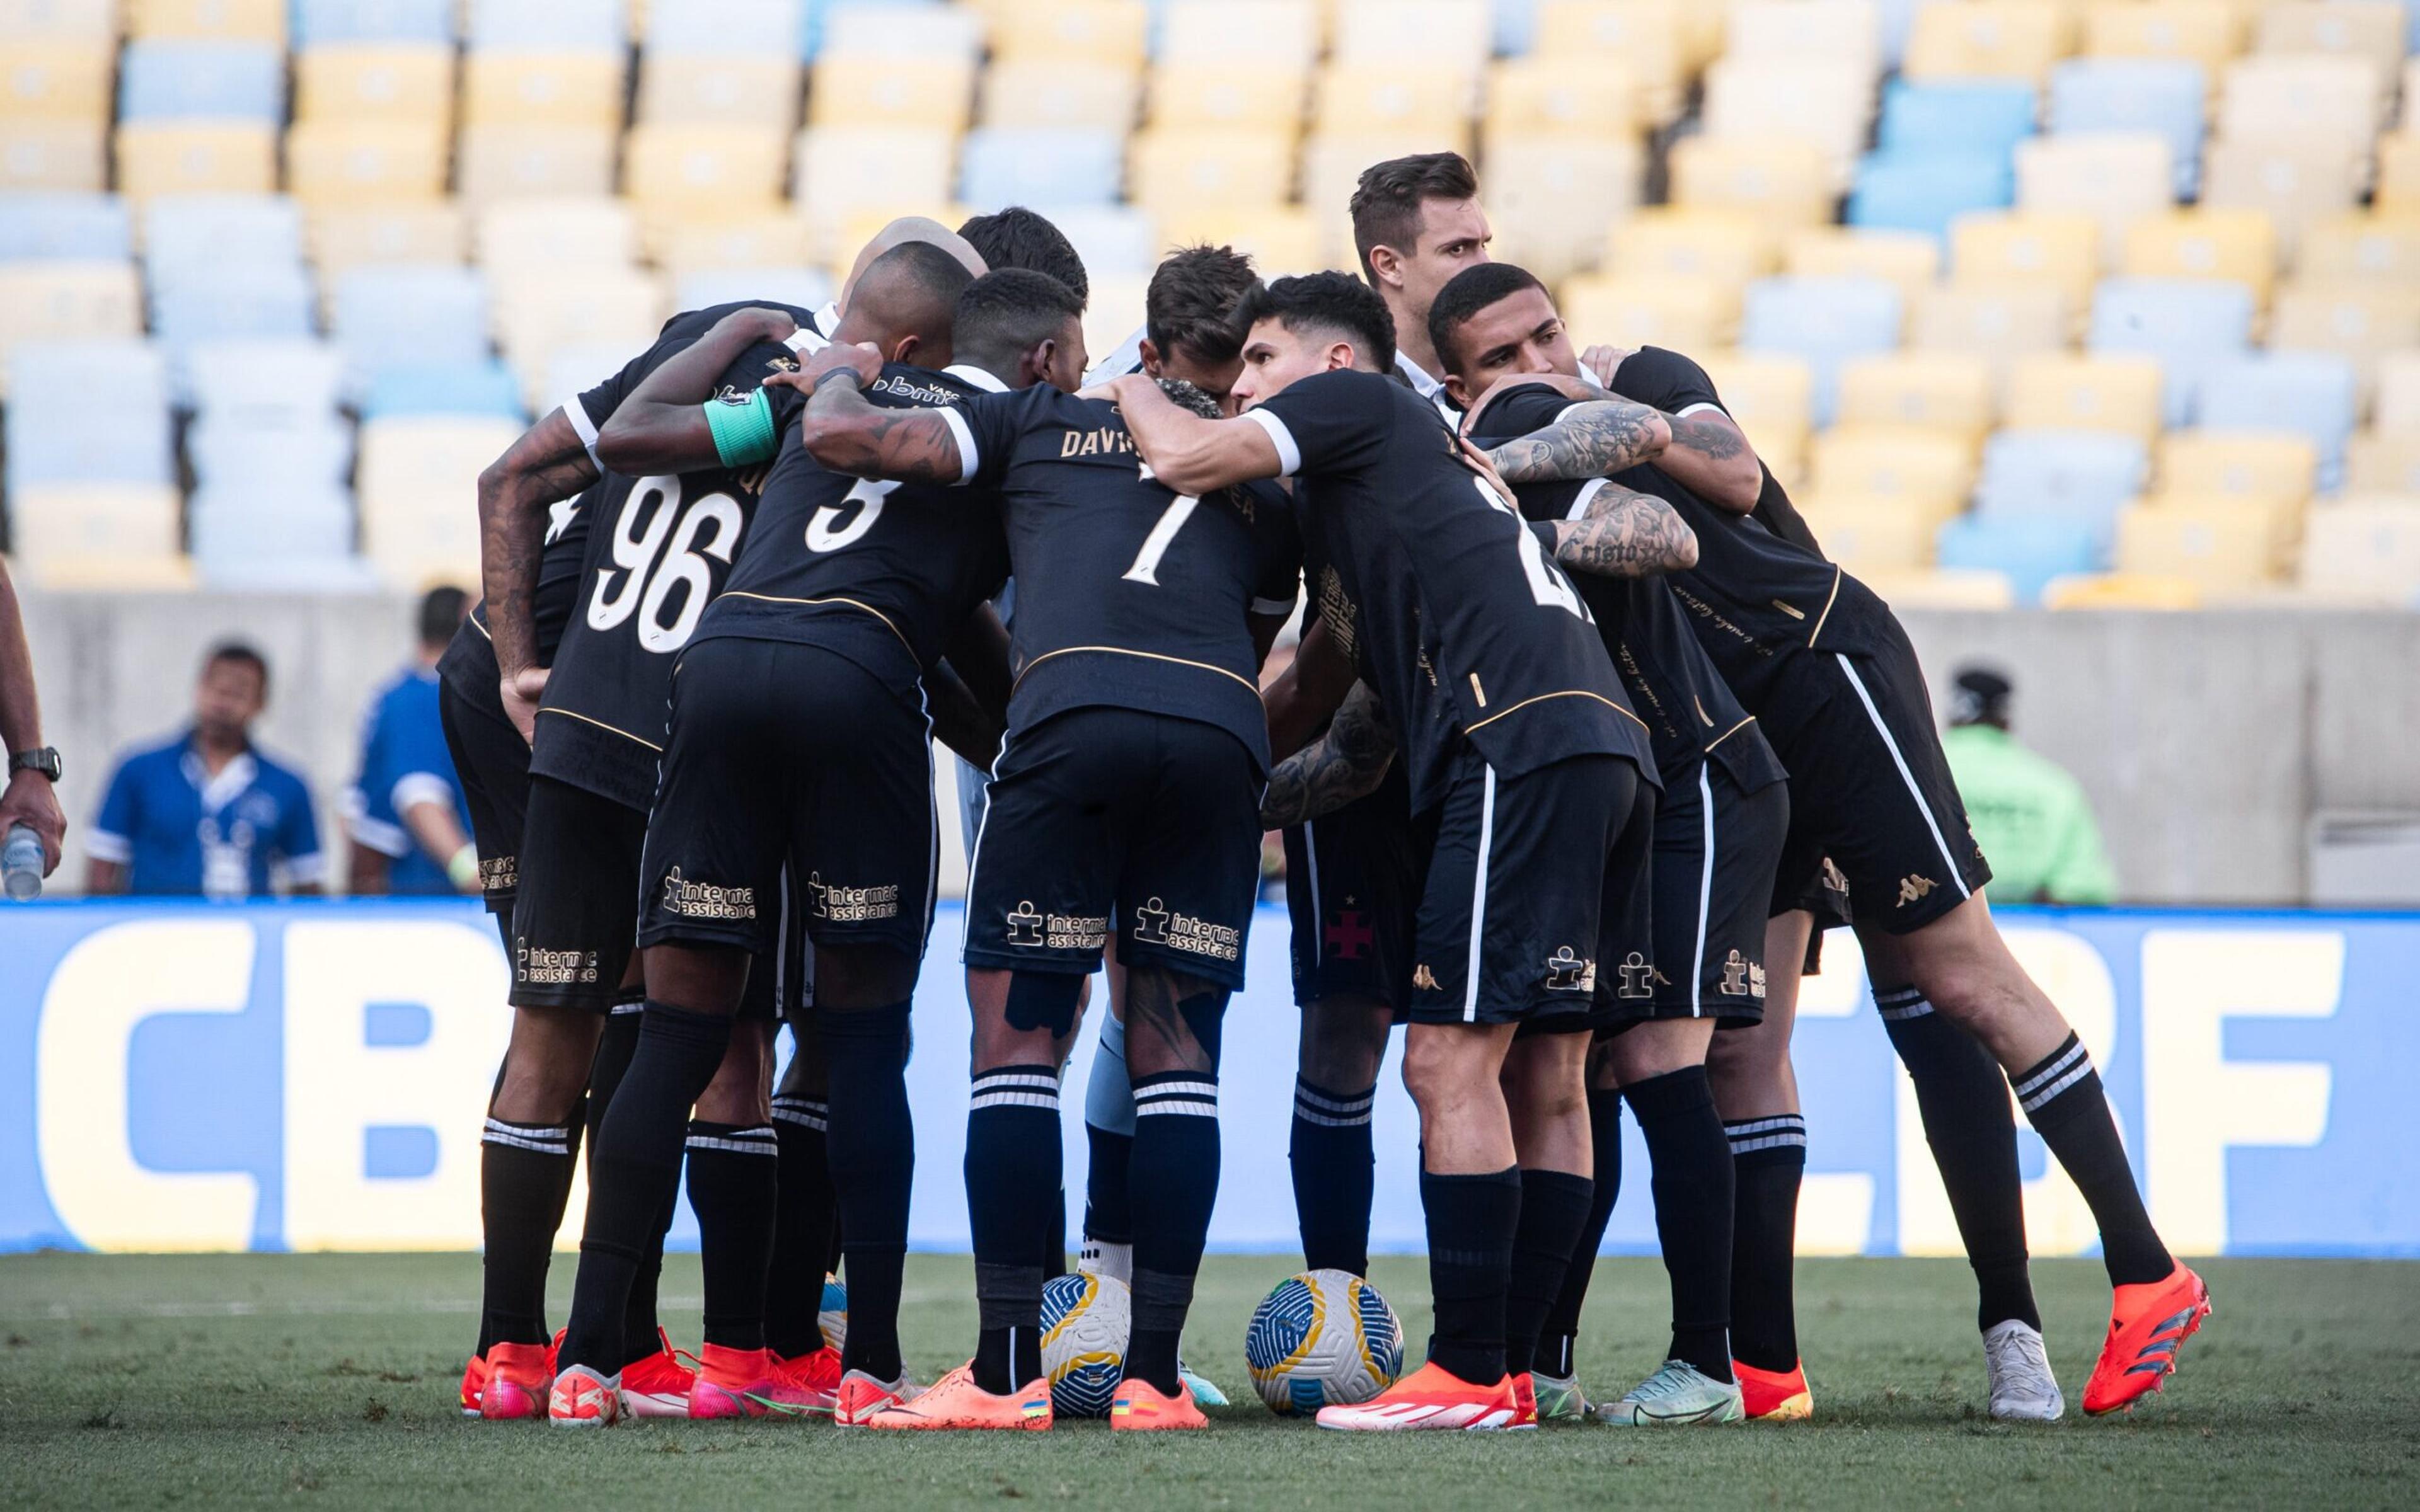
[1248,372,1656,810]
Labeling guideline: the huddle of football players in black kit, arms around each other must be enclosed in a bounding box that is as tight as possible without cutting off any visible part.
[443,152,2210,1429]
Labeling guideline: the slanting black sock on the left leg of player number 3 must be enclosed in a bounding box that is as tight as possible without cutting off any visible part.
[559,1002,731,1369]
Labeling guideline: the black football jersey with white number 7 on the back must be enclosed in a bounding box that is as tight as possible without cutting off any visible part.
[951,368,1302,769]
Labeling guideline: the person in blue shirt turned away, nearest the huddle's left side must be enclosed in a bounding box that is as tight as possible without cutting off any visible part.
[343,588,479,898]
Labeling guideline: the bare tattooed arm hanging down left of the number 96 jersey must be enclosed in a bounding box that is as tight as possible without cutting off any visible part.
[479,399,597,740]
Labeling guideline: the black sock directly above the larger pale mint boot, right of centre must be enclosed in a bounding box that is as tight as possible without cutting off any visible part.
[1622,1067,1732,1382]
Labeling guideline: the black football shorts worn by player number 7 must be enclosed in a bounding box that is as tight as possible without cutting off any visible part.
[965,706,1265,992]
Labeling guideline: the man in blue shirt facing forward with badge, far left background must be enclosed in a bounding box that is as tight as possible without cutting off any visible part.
[84,641,326,902]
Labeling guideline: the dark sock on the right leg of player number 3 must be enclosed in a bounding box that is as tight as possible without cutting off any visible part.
[815,1002,915,1382]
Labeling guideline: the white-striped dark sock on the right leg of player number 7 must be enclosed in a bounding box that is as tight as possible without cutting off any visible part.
[1126,1072,1218,1396]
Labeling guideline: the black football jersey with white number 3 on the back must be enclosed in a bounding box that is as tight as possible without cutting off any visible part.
[689,363,1009,682]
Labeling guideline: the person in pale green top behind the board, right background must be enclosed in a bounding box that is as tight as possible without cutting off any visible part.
[1941,665,2118,902]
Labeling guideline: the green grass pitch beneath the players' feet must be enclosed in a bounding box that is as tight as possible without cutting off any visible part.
[0,1256,2420,1512]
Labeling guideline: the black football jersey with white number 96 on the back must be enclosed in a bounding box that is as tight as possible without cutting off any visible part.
[530,305,815,810]
